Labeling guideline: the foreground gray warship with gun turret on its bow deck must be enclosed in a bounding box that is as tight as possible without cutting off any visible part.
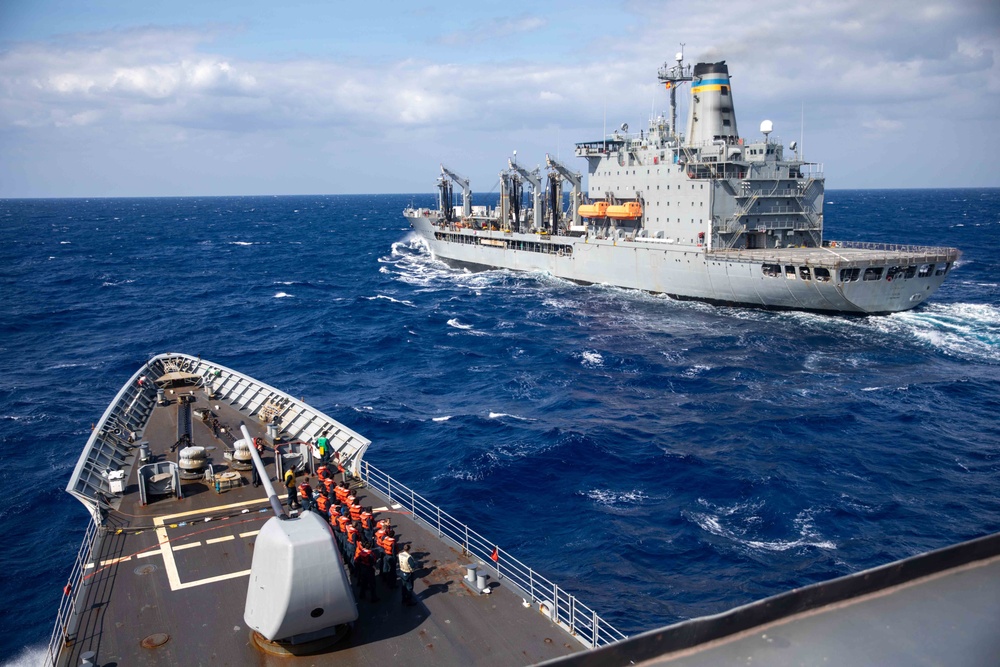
[50,353,1000,667]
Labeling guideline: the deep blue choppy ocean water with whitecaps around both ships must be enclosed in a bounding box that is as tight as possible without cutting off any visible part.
[0,189,1000,663]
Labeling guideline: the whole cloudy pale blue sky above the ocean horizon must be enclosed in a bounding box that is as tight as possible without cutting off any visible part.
[0,0,1000,197]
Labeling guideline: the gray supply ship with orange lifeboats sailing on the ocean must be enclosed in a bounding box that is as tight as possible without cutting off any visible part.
[403,54,961,314]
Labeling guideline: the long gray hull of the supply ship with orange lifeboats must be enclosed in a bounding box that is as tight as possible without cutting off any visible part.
[407,211,954,314]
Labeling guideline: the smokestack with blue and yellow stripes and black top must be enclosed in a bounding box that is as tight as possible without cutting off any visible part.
[687,60,740,146]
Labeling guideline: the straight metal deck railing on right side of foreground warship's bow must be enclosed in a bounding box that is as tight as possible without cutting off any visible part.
[361,461,627,648]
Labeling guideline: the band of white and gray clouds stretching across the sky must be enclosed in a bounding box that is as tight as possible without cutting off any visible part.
[0,0,1000,194]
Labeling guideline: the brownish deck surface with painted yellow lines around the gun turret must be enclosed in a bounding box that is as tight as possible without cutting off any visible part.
[59,390,584,665]
